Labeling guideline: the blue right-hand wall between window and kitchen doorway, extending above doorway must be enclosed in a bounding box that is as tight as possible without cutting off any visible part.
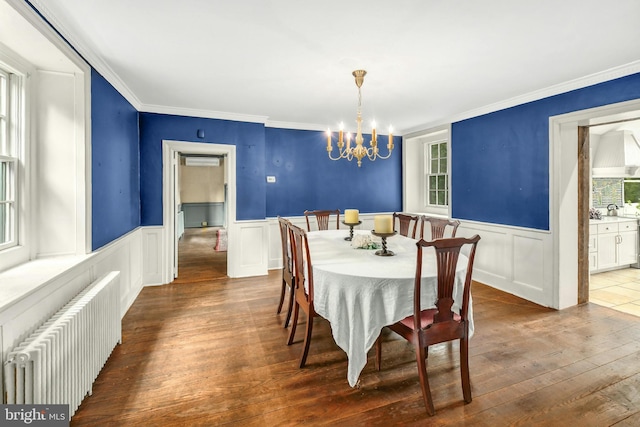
[451,74,640,230]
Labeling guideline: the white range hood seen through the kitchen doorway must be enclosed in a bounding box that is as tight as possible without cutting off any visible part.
[592,130,640,177]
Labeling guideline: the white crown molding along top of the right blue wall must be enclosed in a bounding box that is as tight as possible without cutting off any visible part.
[403,60,640,135]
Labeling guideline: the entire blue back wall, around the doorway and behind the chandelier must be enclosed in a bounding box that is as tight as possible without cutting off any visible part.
[140,113,402,225]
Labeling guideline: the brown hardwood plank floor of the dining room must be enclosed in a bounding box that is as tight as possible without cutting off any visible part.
[71,234,640,427]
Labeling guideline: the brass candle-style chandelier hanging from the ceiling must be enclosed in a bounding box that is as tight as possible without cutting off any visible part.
[327,70,393,167]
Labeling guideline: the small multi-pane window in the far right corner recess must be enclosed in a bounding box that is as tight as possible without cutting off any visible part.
[424,140,449,207]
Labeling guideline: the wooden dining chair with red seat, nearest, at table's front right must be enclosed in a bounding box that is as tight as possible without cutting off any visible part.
[376,234,480,415]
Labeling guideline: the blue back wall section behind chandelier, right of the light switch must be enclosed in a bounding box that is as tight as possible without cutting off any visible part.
[265,128,402,217]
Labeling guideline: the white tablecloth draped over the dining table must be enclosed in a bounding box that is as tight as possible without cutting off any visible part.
[307,229,473,387]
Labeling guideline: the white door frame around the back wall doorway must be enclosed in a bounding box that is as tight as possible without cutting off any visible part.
[162,140,236,283]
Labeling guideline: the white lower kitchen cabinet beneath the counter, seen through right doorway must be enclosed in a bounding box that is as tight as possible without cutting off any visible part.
[589,219,638,270]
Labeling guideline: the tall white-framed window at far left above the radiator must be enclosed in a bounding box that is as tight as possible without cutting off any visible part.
[0,63,20,250]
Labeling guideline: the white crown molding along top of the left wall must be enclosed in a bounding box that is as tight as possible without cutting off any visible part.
[26,0,142,110]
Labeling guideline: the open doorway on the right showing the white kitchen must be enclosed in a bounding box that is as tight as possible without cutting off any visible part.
[587,115,640,316]
